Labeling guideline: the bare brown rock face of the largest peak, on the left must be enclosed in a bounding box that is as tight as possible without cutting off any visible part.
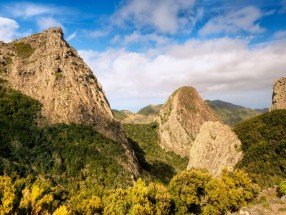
[0,28,138,175]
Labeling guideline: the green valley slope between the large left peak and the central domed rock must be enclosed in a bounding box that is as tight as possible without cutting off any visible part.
[123,123,188,183]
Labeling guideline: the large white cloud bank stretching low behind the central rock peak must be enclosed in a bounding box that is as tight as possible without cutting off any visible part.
[80,38,286,109]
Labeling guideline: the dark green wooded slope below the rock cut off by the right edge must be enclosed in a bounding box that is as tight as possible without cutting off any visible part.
[234,110,286,187]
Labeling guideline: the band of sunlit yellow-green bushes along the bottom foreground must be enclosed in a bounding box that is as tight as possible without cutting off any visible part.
[0,169,259,215]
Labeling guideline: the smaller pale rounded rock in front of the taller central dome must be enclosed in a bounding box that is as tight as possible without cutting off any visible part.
[188,122,243,176]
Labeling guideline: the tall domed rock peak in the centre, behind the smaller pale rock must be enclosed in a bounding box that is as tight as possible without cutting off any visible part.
[157,87,219,157]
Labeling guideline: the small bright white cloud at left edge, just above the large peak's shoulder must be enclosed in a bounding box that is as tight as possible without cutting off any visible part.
[0,17,19,42]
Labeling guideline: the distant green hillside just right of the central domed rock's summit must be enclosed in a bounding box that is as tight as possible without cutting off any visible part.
[206,100,260,126]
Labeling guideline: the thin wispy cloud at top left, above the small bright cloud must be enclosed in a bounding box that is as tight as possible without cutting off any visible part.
[6,2,59,18]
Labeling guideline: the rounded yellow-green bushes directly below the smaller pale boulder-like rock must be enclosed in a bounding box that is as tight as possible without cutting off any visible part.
[169,169,259,214]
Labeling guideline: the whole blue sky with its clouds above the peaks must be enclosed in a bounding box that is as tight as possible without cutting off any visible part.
[0,0,286,111]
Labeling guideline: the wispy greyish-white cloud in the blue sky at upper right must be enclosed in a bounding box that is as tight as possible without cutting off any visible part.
[199,6,264,35]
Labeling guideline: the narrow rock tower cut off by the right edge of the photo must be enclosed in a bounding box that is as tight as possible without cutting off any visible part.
[271,77,286,110]
